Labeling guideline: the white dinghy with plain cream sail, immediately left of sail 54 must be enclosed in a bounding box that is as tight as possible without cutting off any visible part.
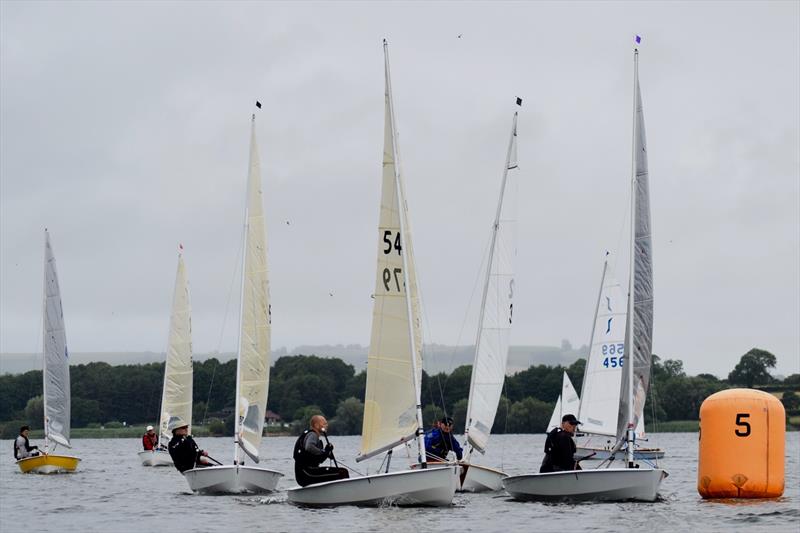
[183,115,283,494]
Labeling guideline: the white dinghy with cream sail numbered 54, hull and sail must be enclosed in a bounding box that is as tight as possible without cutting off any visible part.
[287,40,460,506]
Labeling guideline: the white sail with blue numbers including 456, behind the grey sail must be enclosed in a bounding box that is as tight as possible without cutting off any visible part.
[577,259,627,436]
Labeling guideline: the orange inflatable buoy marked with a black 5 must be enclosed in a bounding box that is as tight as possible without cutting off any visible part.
[697,389,786,498]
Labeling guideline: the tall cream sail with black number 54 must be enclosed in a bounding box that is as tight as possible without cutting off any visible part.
[359,41,424,459]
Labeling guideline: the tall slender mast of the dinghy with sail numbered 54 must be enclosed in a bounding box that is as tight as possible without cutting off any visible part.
[383,39,427,468]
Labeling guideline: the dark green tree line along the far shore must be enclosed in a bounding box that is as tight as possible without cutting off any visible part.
[0,348,800,436]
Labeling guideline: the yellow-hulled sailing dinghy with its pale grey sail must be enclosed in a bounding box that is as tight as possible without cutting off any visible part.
[17,229,80,474]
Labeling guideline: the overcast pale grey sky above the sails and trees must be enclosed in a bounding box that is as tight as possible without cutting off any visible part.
[0,1,800,375]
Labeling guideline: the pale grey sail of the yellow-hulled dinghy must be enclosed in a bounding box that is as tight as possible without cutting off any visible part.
[43,230,71,448]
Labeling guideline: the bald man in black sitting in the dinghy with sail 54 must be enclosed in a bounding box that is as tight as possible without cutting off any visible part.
[293,415,350,487]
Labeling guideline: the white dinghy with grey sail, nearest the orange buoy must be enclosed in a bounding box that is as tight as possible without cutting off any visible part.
[503,44,667,501]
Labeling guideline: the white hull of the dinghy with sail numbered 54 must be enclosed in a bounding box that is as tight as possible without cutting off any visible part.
[287,465,461,507]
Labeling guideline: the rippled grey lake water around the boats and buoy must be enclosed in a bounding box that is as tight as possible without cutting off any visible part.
[0,432,800,533]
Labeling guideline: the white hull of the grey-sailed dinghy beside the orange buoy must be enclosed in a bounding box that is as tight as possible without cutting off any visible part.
[503,468,668,502]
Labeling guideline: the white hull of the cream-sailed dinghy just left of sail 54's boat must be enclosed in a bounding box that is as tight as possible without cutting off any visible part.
[183,465,283,494]
